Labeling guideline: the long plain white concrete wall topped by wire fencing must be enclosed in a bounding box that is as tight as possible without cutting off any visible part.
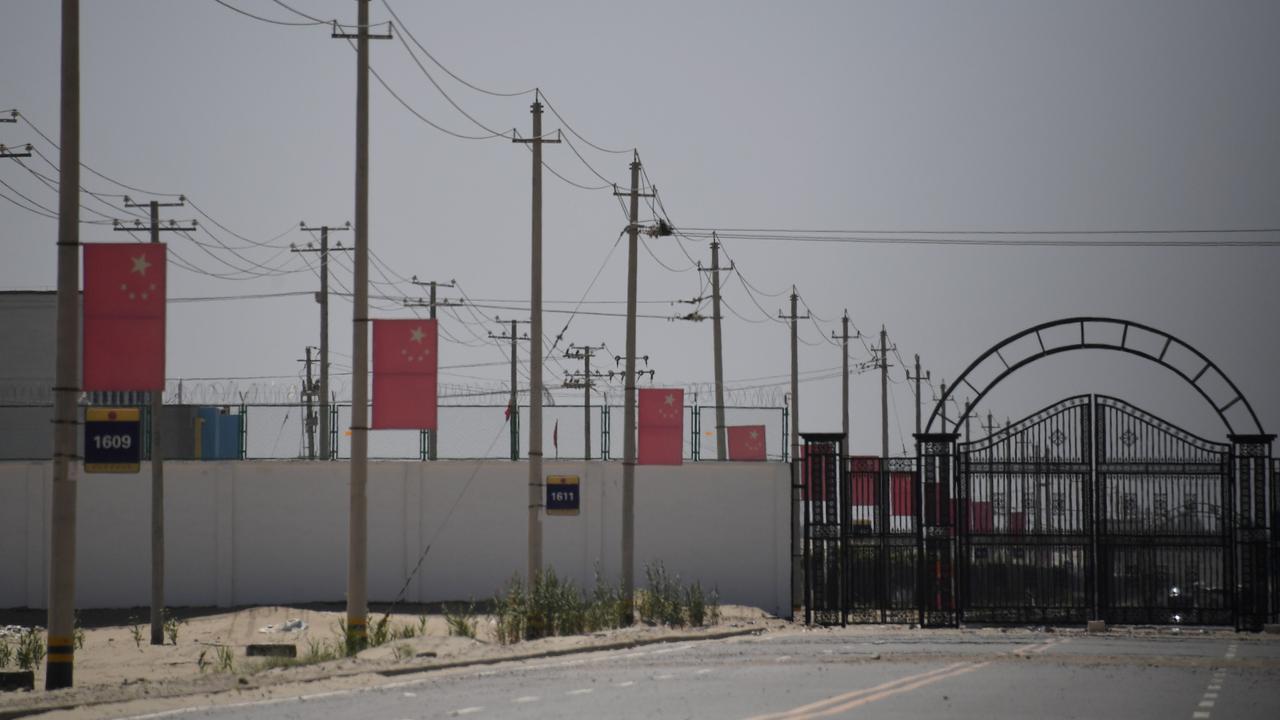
[0,460,790,614]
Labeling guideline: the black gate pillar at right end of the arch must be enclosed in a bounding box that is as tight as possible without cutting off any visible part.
[1229,434,1280,632]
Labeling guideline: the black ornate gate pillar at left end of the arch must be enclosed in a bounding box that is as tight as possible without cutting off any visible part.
[911,433,965,628]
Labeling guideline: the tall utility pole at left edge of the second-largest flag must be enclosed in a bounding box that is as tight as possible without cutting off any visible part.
[332,0,392,650]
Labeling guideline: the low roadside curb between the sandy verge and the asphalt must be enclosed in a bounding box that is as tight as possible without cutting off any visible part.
[0,626,768,720]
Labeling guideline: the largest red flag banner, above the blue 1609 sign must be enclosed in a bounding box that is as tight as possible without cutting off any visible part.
[81,242,165,391]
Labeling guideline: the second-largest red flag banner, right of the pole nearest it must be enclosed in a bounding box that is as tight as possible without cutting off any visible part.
[372,320,439,430]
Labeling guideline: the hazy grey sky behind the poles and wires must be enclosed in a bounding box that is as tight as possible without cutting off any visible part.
[0,0,1280,450]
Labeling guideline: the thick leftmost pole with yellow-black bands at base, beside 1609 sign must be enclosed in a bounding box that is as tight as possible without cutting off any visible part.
[45,0,81,691]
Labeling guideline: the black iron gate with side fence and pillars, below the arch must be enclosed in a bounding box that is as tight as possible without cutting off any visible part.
[805,396,1280,629]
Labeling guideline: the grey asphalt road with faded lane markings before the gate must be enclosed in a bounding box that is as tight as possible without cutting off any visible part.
[122,629,1280,720]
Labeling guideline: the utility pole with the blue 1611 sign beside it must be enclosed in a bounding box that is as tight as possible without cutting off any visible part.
[512,90,559,587]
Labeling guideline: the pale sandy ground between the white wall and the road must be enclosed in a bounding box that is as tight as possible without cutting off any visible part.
[0,605,790,720]
